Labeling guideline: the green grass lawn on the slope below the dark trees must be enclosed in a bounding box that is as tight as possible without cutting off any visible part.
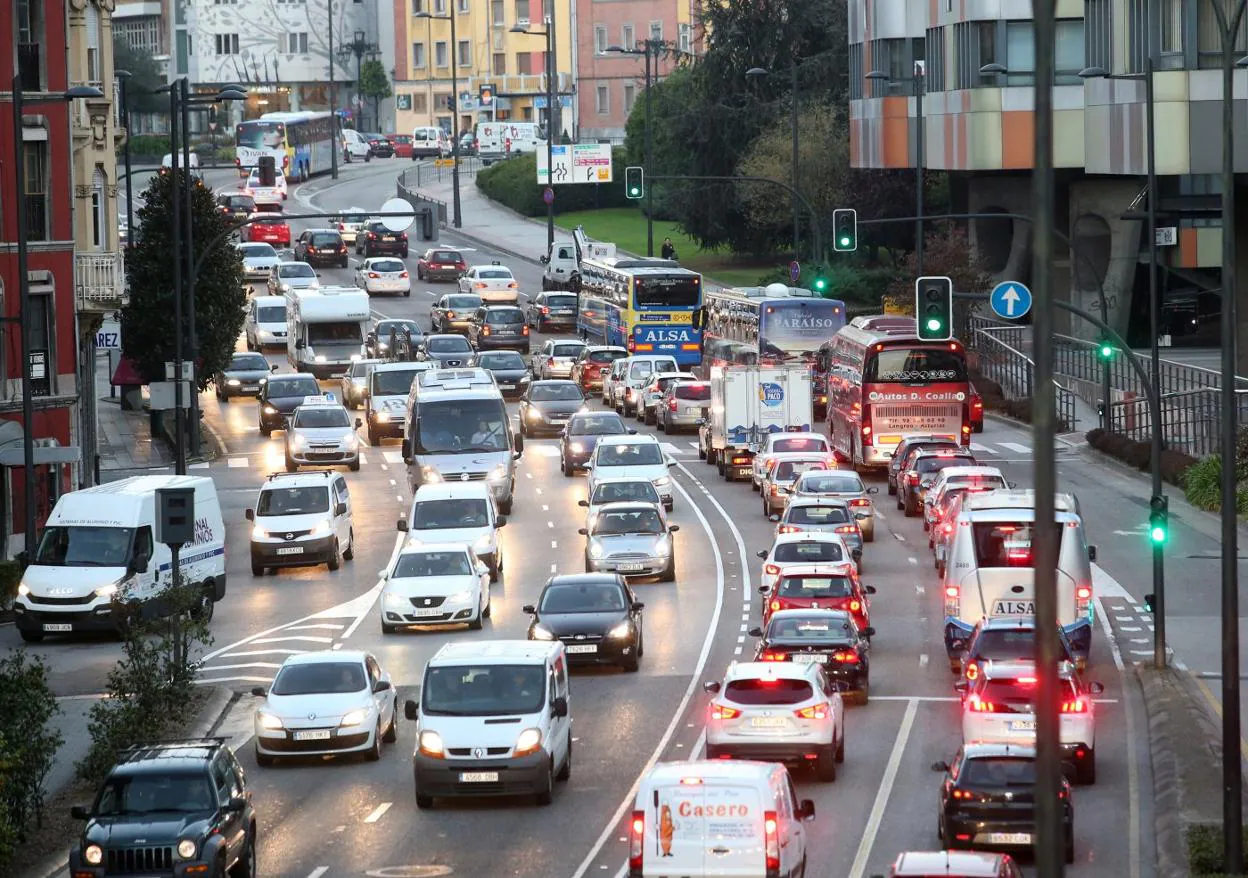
[555,207,780,287]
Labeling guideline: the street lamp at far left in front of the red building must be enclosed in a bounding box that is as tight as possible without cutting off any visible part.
[12,74,104,564]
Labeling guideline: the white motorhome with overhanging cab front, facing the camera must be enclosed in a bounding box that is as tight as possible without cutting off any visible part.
[286,287,368,378]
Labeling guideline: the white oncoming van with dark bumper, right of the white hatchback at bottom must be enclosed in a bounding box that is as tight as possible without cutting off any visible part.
[403,640,572,809]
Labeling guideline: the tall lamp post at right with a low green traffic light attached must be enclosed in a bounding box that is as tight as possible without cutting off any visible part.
[1080,61,1167,670]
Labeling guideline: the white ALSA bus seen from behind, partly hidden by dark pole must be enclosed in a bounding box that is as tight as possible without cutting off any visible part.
[942,490,1096,667]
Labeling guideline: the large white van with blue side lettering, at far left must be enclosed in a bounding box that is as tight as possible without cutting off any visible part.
[14,475,226,642]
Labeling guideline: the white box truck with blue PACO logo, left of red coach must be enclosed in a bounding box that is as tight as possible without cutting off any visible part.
[698,364,814,481]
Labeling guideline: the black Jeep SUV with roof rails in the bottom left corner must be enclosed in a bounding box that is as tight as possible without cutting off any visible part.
[70,738,256,878]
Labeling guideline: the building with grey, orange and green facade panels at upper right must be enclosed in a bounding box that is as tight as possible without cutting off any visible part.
[849,0,1248,344]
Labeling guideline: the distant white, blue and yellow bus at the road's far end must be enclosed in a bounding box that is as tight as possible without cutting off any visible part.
[235,112,334,182]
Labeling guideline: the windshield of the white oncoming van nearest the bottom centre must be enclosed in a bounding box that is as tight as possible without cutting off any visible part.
[421,665,547,716]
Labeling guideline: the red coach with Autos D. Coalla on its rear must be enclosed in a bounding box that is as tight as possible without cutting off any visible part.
[815,317,971,468]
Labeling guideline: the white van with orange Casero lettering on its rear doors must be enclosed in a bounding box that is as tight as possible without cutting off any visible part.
[628,760,815,878]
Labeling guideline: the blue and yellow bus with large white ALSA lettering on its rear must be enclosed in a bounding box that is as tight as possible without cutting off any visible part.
[577,257,703,367]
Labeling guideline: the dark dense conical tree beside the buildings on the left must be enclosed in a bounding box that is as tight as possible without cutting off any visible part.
[121,175,247,390]
